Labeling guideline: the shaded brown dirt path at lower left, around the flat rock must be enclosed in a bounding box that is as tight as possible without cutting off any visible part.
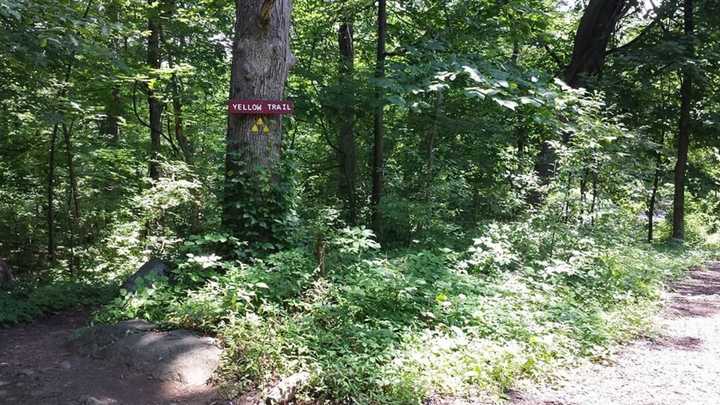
[0,312,221,405]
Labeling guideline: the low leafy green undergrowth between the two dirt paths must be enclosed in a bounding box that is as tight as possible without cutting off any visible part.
[97,208,716,404]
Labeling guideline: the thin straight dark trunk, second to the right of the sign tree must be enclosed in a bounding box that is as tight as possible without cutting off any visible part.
[370,0,387,239]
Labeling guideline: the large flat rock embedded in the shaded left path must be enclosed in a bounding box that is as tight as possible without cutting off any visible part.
[69,320,222,385]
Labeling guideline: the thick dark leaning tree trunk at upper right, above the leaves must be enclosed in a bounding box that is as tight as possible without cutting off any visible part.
[564,0,627,87]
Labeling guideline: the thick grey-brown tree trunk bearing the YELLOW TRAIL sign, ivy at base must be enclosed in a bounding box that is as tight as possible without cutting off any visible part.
[223,0,294,242]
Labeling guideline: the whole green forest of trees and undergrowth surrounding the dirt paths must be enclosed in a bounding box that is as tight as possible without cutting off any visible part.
[0,0,720,404]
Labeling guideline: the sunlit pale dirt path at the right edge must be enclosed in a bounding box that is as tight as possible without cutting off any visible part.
[511,263,720,405]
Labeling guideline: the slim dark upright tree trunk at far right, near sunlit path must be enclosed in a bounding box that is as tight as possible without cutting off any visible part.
[672,0,695,240]
